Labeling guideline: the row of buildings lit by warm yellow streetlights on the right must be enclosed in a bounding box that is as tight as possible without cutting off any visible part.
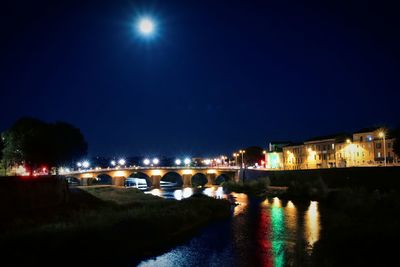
[267,127,400,170]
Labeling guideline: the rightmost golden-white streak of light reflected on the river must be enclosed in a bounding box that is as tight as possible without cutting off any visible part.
[305,201,320,249]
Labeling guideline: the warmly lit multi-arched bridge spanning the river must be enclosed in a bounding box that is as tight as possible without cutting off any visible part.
[62,167,240,188]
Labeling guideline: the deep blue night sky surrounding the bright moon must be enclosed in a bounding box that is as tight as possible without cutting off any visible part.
[0,0,400,156]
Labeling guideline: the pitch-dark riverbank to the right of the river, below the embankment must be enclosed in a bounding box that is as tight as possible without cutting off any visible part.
[313,188,400,266]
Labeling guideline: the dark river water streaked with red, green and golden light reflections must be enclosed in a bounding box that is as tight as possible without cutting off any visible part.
[139,187,321,267]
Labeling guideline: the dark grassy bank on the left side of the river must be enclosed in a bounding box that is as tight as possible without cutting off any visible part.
[0,187,230,266]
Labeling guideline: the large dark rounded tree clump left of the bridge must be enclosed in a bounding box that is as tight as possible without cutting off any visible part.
[3,118,87,173]
